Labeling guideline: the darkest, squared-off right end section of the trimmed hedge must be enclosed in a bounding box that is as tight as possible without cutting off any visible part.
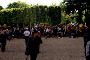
[49,6,61,25]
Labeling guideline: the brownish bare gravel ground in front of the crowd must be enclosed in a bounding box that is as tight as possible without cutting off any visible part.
[0,37,85,60]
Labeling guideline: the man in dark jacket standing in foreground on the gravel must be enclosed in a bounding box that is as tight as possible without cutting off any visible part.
[25,31,42,60]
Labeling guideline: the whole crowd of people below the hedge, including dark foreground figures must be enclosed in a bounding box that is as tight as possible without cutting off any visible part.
[0,23,90,60]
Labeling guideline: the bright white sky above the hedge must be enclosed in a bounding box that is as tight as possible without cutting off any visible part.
[0,0,63,8]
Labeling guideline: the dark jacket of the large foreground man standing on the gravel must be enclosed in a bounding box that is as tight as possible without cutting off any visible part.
[25,36,42,55]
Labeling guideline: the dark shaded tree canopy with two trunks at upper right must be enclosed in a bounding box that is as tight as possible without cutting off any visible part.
[64,0,90,24]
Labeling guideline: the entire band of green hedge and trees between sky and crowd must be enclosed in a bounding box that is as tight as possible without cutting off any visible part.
[0,0,89,25]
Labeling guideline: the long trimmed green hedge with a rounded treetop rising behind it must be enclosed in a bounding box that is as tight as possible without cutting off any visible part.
[0,1,61,26]
